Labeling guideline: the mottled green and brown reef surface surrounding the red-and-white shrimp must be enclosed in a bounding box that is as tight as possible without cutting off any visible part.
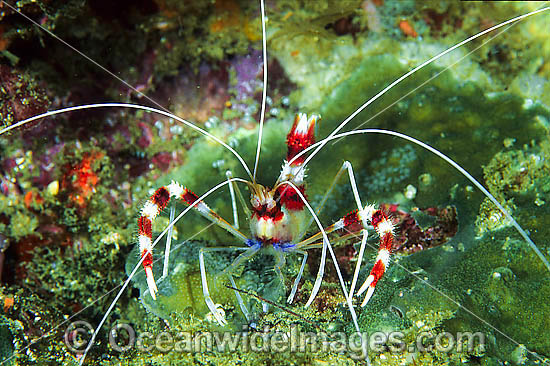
[0,0,550,365]
